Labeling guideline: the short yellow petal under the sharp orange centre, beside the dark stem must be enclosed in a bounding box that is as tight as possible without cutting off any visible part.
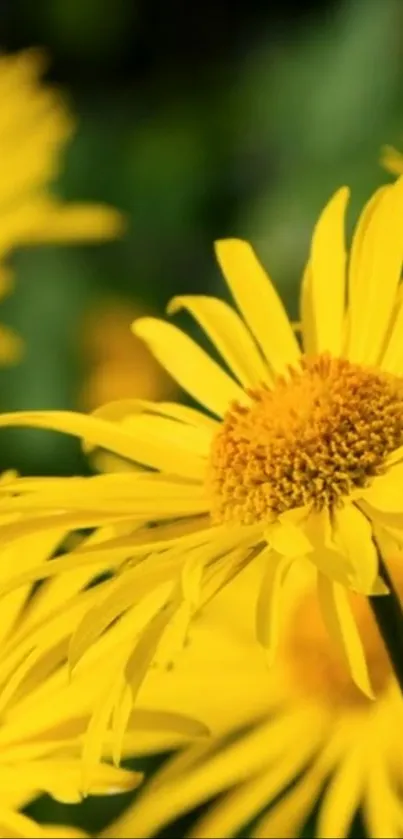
[333,504,378,594]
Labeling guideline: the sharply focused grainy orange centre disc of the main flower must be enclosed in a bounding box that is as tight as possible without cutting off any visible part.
[207,354,403,524]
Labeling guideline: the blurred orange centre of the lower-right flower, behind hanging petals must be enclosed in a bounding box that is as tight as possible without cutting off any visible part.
[281,556,403,707]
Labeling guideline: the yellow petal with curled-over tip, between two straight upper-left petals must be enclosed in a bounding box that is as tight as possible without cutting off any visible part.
[168,295,271,387]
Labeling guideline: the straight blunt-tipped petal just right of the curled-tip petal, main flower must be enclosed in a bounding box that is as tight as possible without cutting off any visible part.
[216,239,300,373]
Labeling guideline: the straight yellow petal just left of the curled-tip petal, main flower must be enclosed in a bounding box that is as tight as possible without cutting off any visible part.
[132,318,245,416]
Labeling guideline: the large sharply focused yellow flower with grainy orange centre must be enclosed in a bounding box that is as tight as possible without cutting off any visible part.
[0,179,403,716]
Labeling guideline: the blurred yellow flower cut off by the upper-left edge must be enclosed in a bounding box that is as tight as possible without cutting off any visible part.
[0,50,123,364]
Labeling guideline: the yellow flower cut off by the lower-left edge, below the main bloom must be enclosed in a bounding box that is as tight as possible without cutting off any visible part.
[0,508,144,837]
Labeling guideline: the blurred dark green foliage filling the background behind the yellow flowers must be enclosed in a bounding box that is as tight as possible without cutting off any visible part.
[0,0,403,835]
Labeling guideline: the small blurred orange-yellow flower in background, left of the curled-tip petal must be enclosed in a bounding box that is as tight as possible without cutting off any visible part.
[80,298,176,411]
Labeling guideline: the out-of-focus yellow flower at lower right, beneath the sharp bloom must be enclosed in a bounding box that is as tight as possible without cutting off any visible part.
[104,557,403,839]
